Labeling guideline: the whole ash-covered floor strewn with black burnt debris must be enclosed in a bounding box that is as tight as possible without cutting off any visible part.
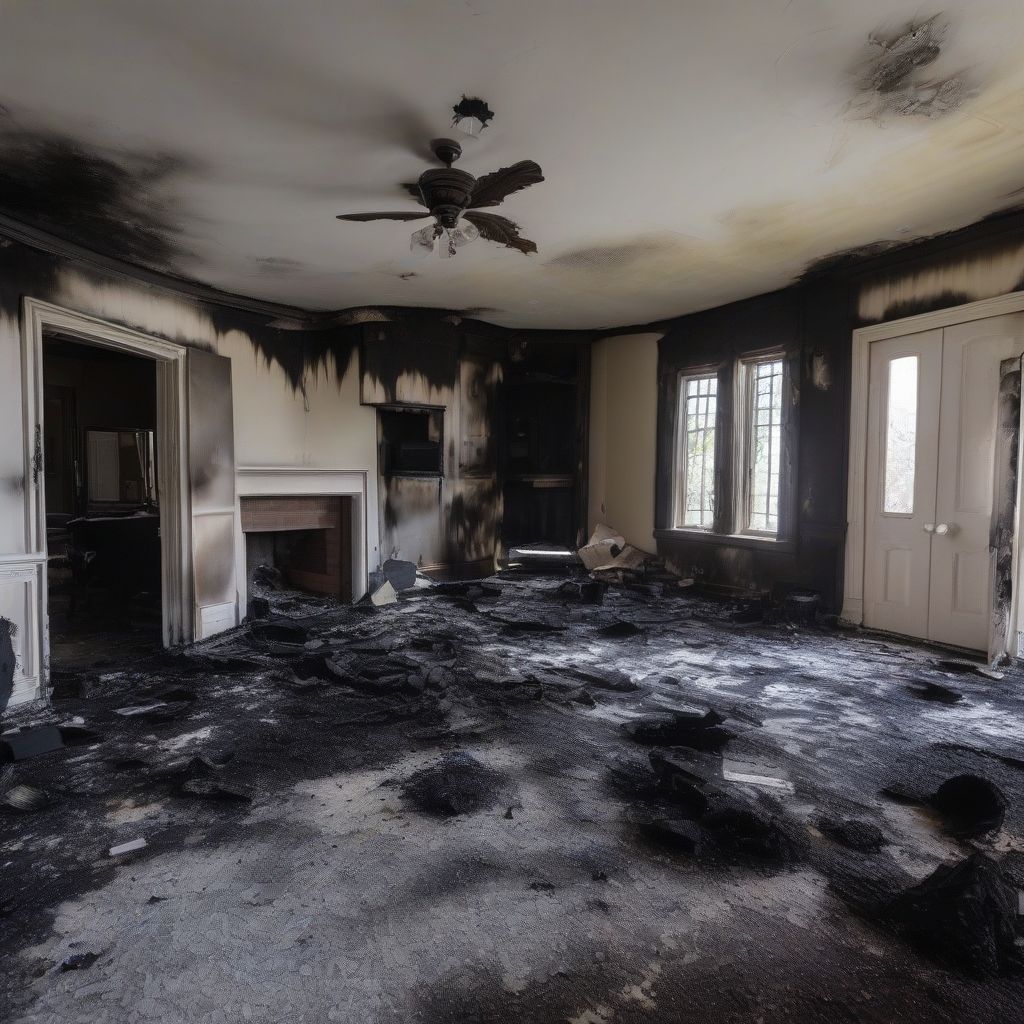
[0,573,1024,1024]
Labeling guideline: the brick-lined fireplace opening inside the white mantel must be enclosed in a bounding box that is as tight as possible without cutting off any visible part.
[240,495,353,601]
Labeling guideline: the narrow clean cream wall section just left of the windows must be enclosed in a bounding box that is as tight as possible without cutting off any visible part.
[588,334,662,551]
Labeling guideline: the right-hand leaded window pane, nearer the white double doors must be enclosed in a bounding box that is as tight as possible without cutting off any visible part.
[738,355,784,535]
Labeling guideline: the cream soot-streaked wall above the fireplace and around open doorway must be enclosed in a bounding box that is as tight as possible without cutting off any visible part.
[0,260,380,701]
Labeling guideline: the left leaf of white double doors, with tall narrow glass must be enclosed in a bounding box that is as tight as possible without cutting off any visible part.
[864,330,942,639]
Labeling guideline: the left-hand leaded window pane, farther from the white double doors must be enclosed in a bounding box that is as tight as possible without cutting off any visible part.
[675,374,718,529]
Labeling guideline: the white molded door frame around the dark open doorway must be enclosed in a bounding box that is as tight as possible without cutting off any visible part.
[22,296,193,686]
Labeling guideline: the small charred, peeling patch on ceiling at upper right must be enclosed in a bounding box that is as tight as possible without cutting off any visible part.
[850,14,974,120]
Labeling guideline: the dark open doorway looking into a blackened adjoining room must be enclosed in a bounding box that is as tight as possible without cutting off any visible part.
[42,334,163,670]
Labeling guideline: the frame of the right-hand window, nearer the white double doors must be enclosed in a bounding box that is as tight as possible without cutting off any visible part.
[732,348,790,543]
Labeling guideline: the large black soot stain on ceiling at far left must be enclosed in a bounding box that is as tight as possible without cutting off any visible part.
[0,108,188,272]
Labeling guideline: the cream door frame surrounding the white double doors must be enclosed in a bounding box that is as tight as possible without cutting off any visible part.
[840,291,1024,646]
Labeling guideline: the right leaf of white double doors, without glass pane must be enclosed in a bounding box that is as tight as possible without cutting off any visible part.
[928,313,1024,650]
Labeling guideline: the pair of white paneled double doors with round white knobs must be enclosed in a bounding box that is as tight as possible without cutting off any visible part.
[864,313,1024,650]
